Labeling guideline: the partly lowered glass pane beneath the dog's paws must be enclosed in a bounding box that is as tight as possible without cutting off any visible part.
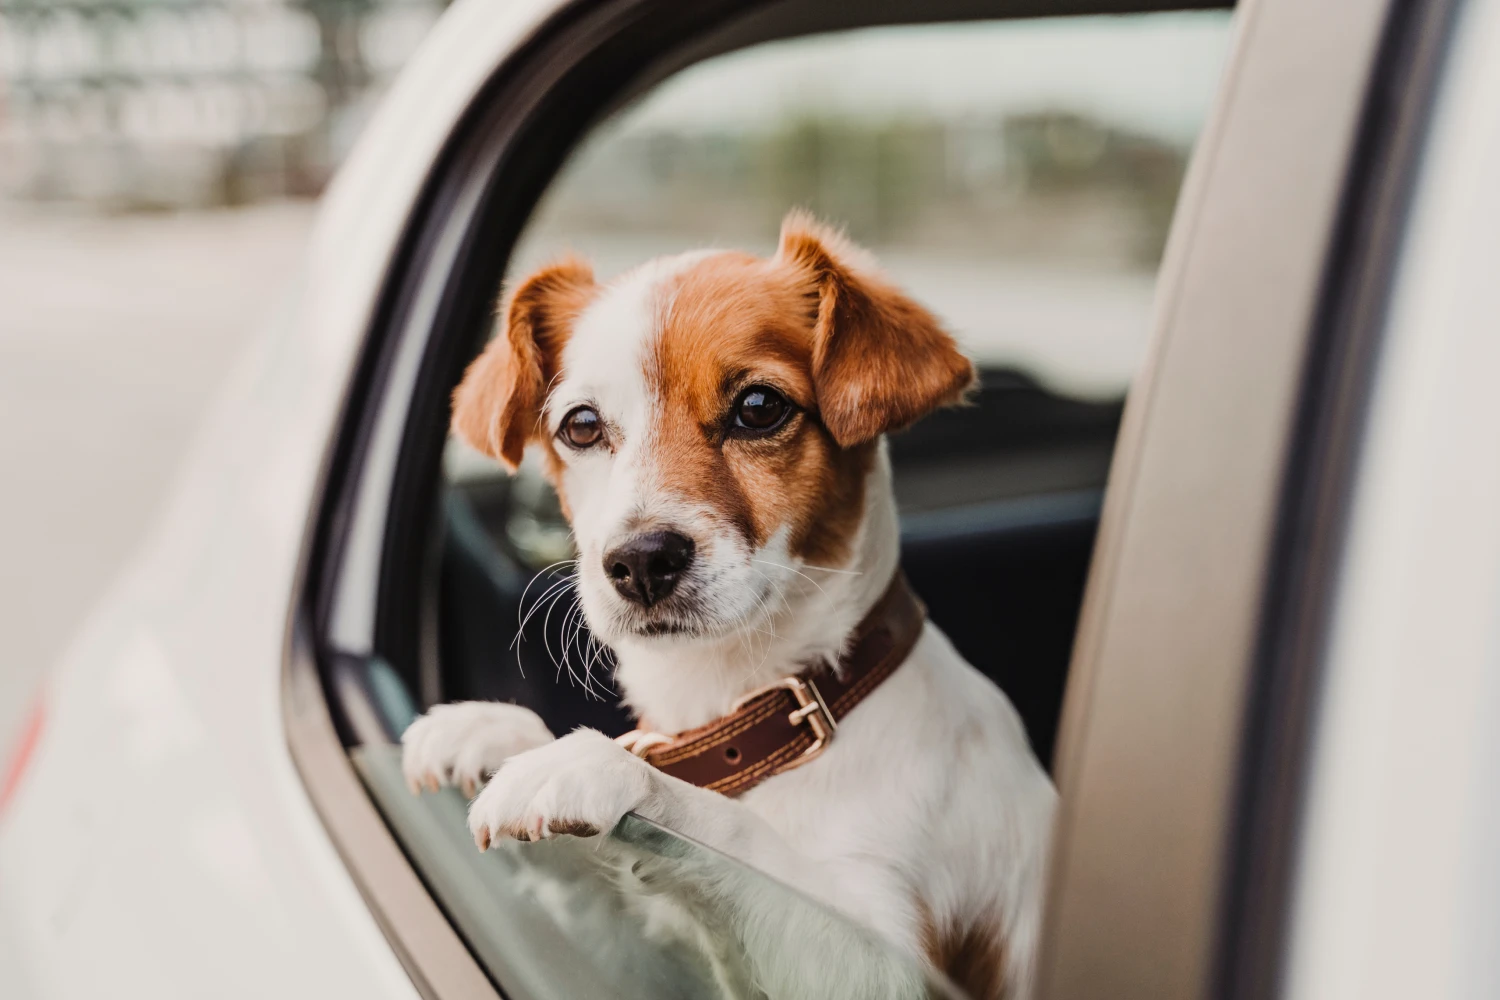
[353,745,962,1000]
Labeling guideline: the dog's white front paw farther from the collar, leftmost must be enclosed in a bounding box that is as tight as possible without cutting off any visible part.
[401,702,552,798]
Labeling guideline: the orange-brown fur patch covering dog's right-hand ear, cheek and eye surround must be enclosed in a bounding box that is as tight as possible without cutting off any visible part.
[648,213,974,564]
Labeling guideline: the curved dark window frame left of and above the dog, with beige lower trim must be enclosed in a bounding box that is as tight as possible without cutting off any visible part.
[282,0,1232,1000]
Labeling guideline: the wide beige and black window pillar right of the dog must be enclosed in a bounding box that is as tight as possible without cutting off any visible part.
[1040,0,1457,1000]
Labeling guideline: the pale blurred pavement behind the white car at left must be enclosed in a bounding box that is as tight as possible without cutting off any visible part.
[0,204,311,746]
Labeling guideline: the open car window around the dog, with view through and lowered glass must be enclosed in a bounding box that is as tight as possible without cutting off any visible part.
[414,12,1230,996]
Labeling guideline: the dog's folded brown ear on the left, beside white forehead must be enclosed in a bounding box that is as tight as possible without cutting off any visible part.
[452,258,596,472]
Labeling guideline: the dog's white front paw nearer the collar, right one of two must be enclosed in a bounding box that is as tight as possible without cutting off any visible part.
[470,729,656,850]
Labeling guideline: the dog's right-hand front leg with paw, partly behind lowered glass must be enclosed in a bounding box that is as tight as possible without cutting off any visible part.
[470,729,926,1000]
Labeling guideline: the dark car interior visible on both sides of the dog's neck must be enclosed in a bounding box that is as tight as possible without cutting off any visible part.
[423,370,1121,762]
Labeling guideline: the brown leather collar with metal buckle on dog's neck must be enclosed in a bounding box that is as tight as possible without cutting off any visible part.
[618,570,927,795]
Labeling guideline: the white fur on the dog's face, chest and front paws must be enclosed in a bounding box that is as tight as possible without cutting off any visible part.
[404,255,1055,997]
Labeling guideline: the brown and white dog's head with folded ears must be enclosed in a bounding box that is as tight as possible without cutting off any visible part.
[453,213,974,642]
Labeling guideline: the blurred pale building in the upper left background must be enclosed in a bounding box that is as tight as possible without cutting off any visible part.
[0,0,446,208]
